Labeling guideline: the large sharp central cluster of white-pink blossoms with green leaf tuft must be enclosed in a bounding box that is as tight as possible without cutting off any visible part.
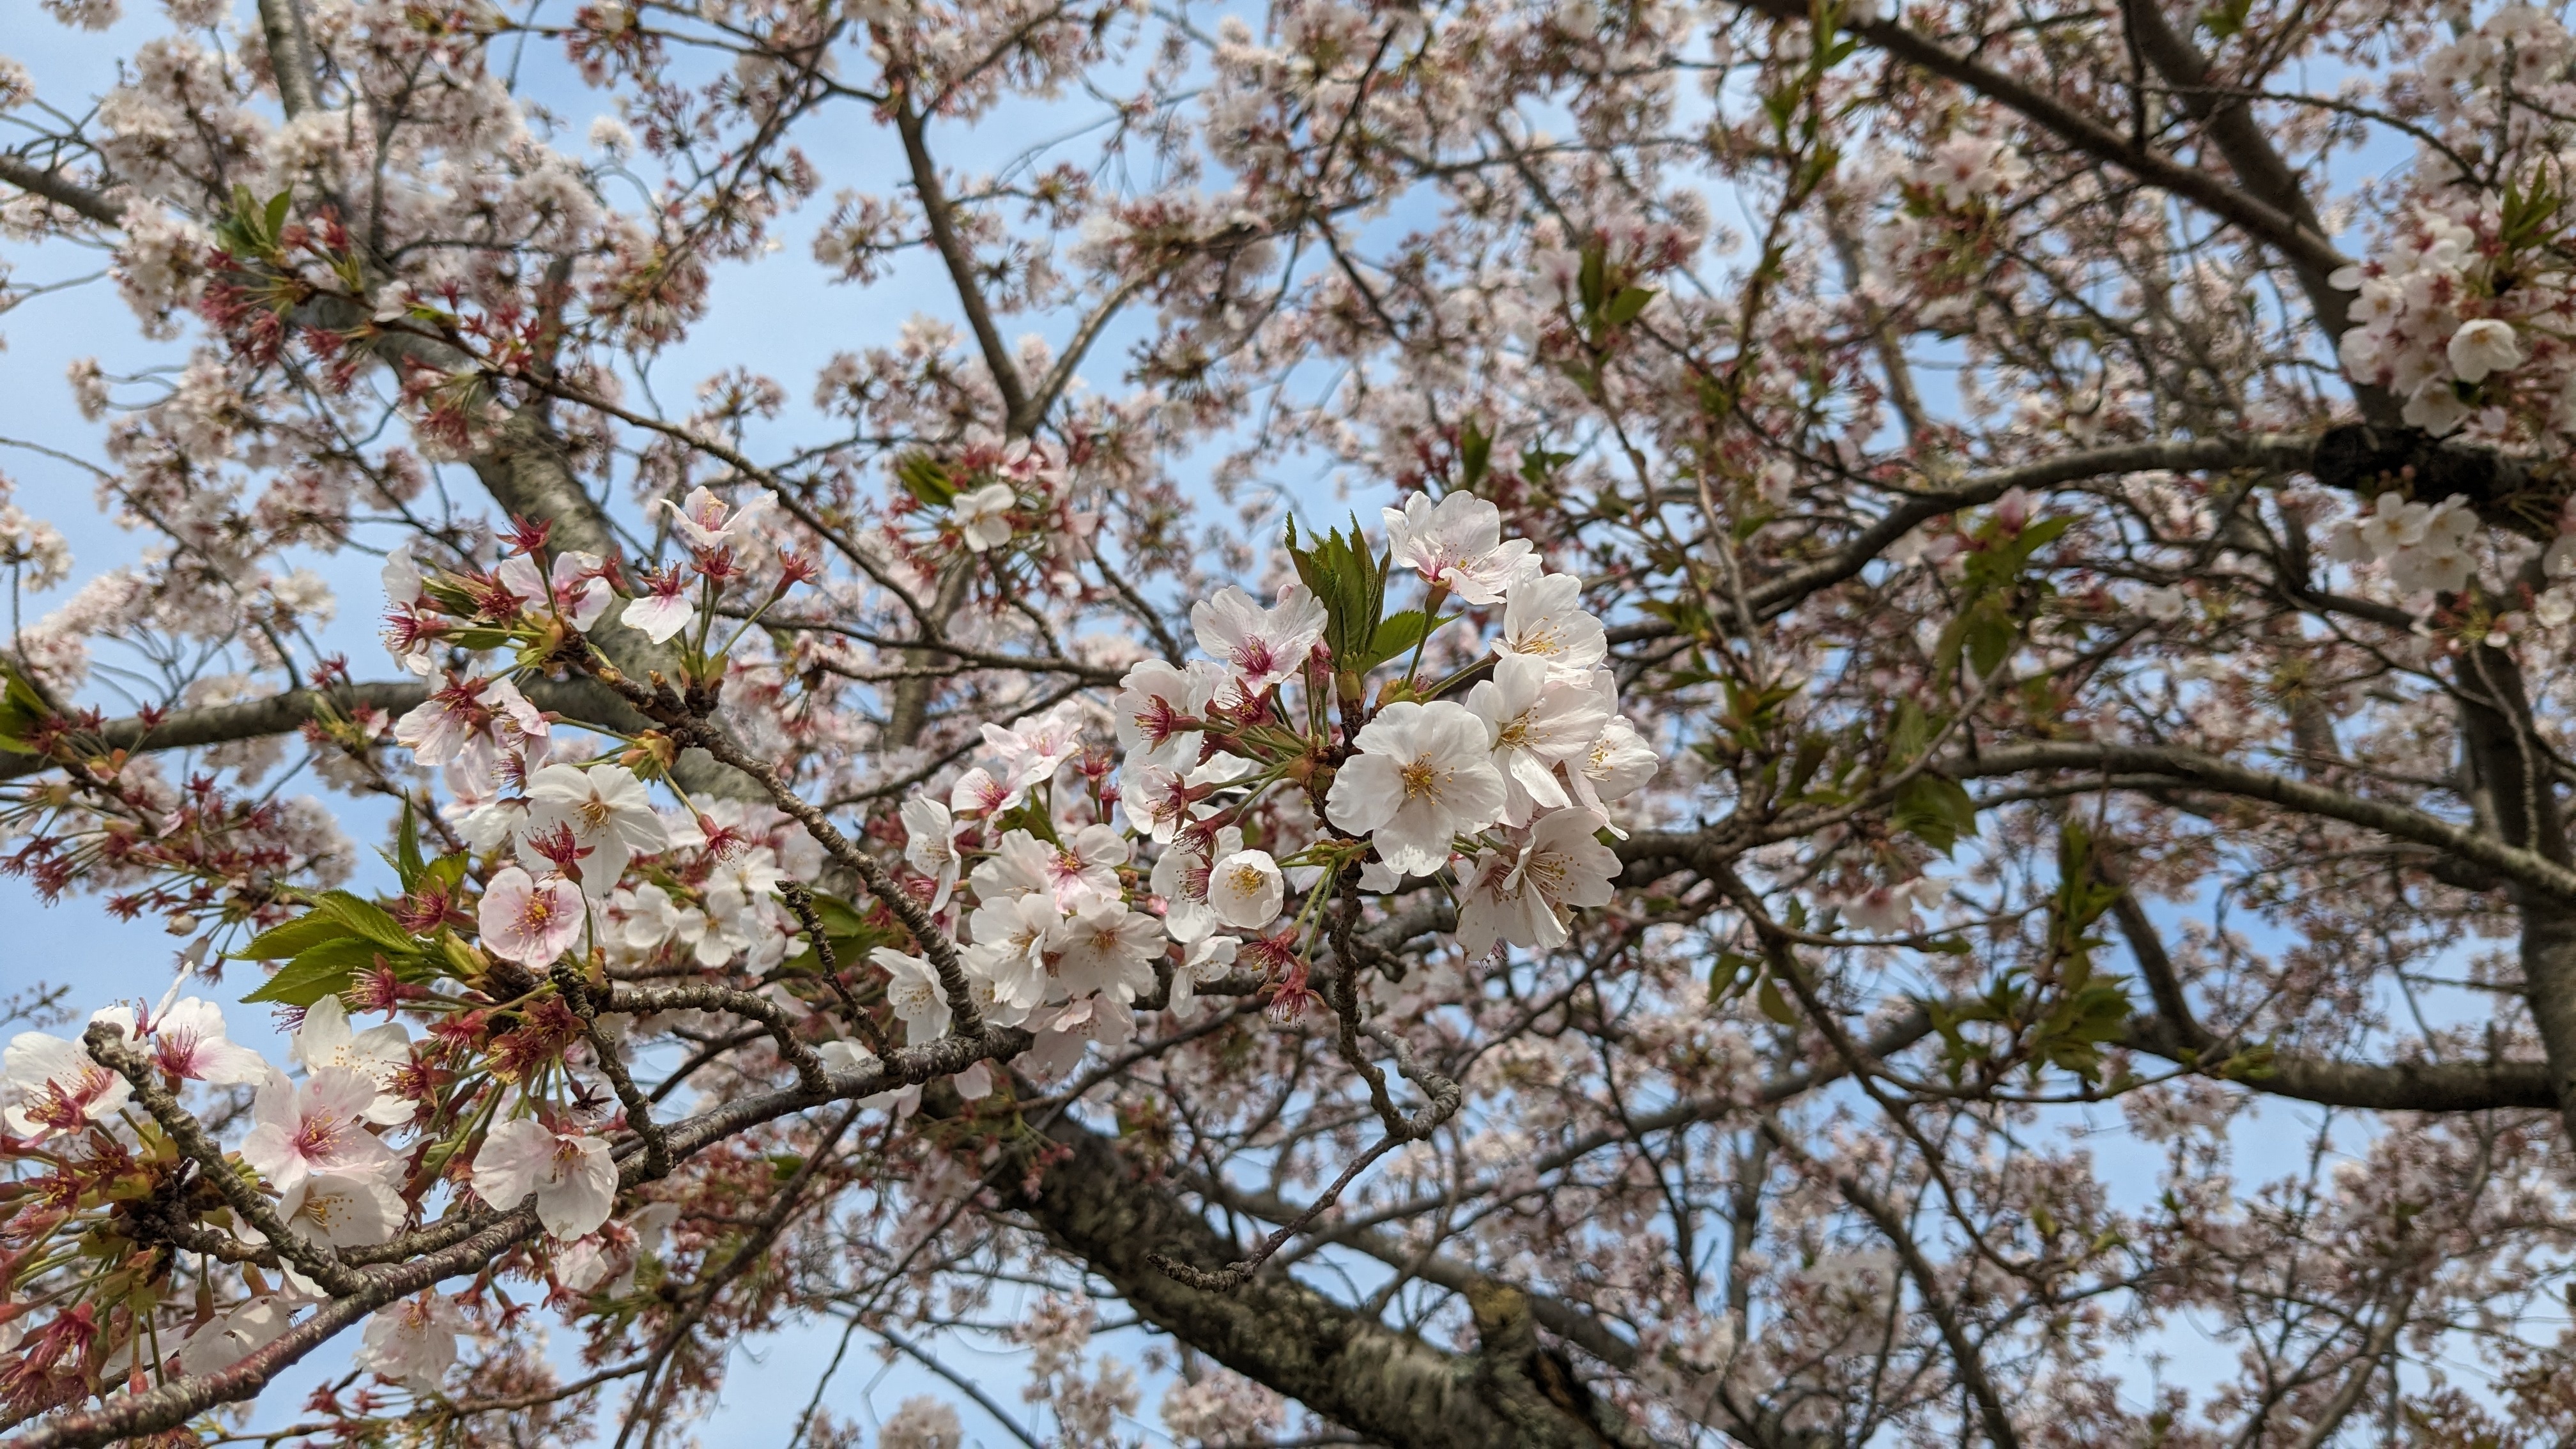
[878,493,1657,1057]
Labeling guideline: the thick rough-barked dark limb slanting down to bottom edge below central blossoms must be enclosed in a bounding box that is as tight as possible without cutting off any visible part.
[1010,1098,1646,1449]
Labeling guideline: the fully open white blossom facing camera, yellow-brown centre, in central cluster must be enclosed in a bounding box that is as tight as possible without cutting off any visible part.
[1324,699,1505,877]
